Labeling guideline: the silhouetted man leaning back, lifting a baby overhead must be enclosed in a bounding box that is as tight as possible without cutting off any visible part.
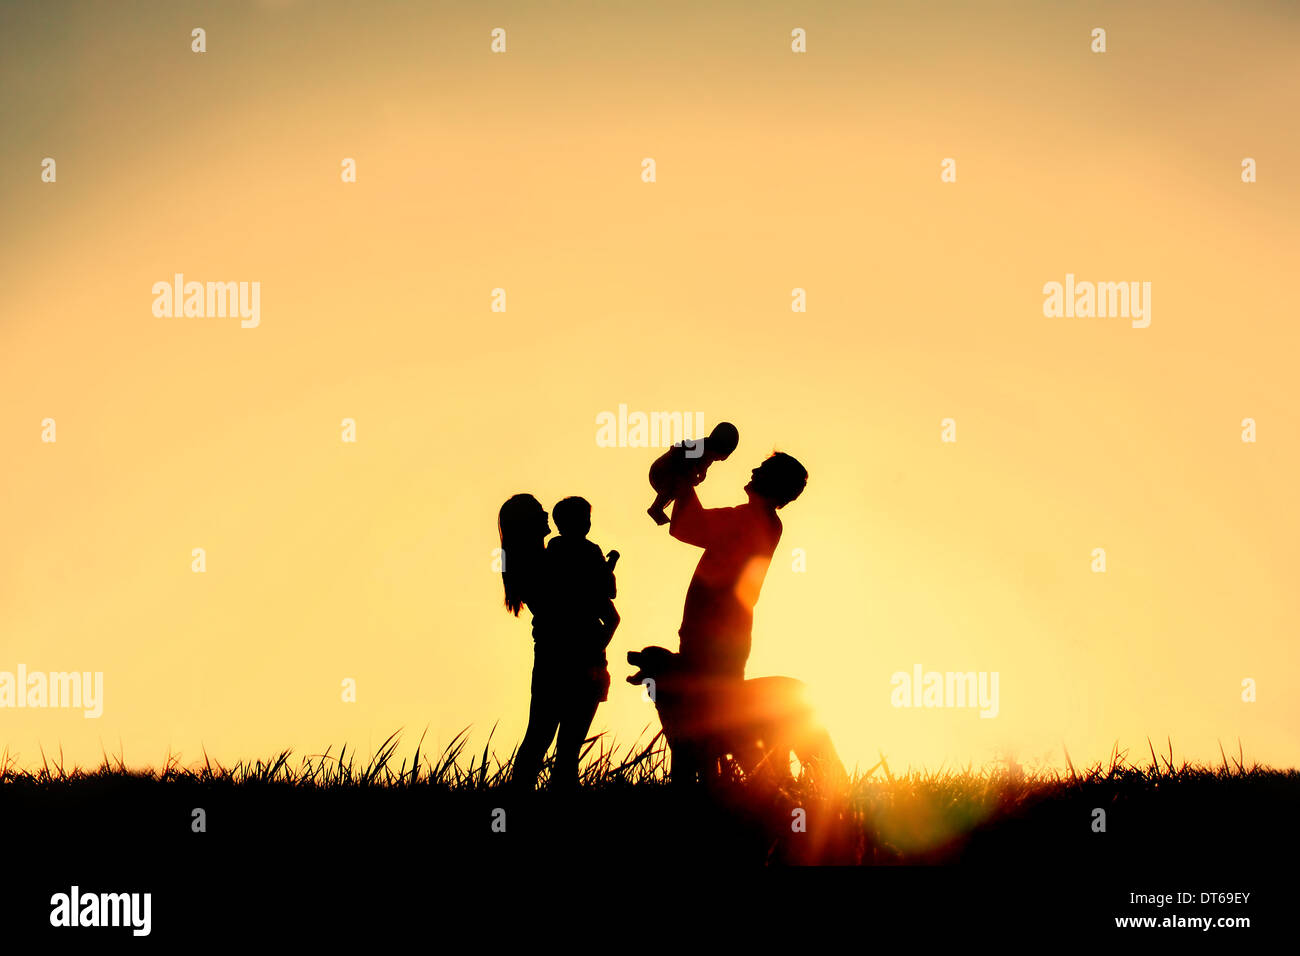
[668,451,809,783]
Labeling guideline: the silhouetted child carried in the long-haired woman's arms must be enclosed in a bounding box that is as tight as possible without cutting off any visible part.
[546,497,619,702]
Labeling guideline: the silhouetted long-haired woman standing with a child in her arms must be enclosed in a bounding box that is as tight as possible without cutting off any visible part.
[497,494,608,790]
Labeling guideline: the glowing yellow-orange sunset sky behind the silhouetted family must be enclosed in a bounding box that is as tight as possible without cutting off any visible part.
[0,1,1300,770]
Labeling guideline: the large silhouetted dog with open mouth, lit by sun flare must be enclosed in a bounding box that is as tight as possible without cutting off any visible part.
[628,646,846,787]
